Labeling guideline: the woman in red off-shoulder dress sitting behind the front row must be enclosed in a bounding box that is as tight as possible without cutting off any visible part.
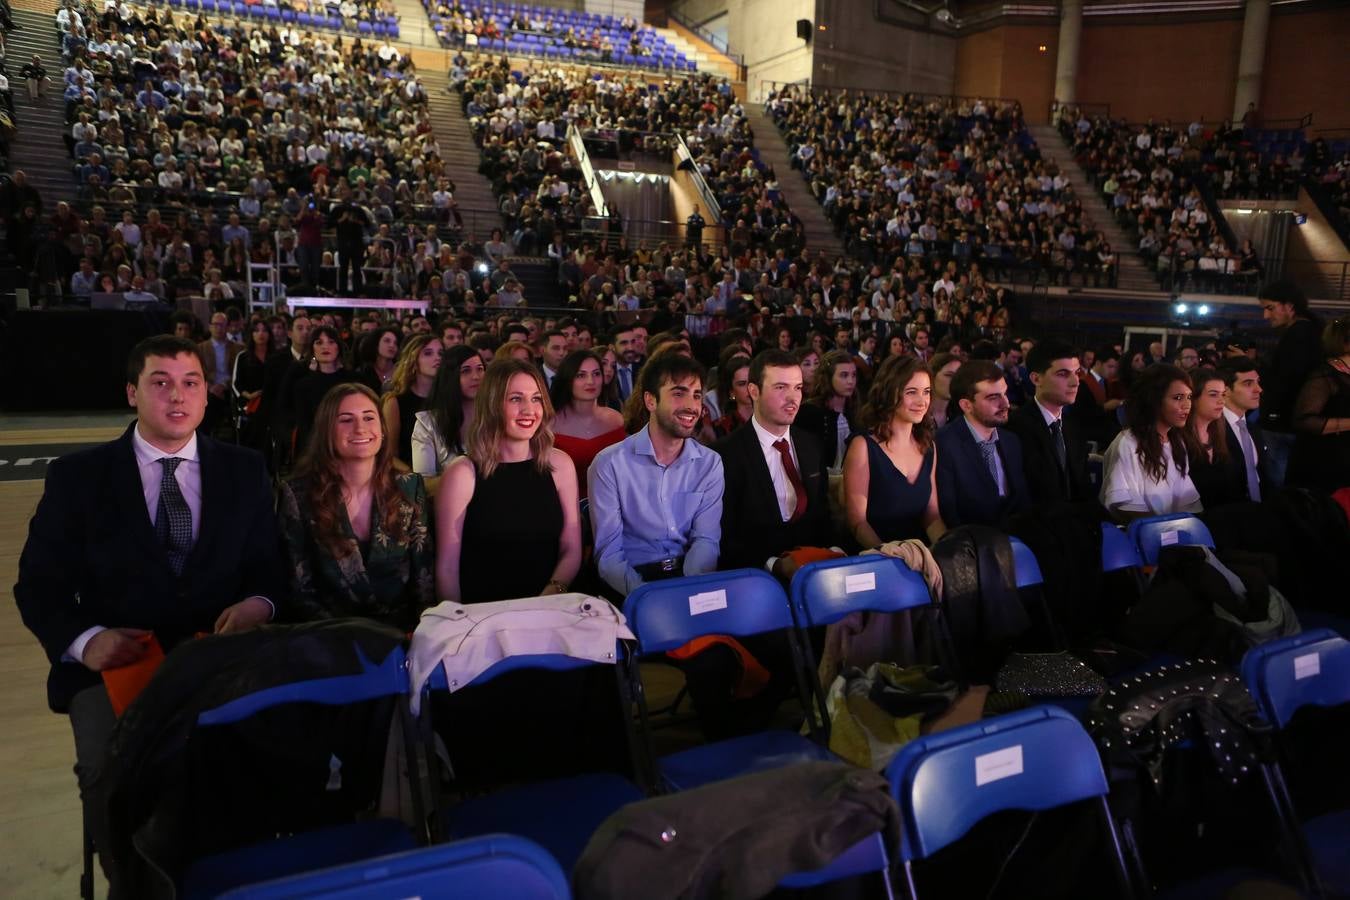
[548,349,626,498]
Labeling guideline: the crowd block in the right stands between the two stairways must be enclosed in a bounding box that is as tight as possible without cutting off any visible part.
[768,89,1115,290]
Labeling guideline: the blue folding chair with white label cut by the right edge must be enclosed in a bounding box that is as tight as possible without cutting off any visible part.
[1242,629,1350,896]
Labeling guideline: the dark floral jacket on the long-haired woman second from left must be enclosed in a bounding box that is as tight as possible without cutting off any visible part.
[278,474,436,631]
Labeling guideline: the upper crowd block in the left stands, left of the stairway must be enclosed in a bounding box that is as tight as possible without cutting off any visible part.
[66,0,443,229]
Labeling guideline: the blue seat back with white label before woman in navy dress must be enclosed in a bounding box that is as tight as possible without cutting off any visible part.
[790,553,932,627]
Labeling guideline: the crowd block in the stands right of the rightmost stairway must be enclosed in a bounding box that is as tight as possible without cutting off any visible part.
[1060,109,1261,293]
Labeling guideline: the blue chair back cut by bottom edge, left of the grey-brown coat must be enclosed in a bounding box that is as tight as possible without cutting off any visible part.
[221,834,571,900]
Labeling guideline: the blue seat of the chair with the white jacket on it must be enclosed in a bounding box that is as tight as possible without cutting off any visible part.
[444,773,643,873]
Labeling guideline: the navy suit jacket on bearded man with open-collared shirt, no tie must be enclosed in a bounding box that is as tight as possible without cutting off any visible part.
[937,416,1031,528]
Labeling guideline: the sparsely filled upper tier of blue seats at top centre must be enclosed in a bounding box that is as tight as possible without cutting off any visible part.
[423,0,698,72]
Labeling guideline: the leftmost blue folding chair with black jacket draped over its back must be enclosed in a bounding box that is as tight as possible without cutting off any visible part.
[182,648,421,897]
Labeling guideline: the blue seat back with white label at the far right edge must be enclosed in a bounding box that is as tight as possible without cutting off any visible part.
[1242,629,1350,729]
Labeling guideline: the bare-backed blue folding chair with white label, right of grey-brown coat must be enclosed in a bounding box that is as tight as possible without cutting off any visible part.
[886,706,1130,897]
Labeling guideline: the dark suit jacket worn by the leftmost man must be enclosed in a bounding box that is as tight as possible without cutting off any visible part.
[14,425,286,712]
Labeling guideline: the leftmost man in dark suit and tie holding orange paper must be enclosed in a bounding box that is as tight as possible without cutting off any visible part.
[14,336,285,892]
